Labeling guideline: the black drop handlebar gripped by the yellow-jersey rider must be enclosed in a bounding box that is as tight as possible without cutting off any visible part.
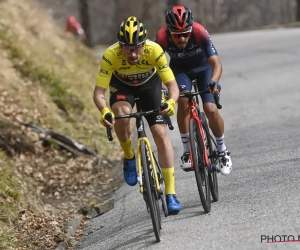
[105,103,174,141]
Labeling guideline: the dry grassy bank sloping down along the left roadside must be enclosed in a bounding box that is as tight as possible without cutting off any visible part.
[0,0,119,249]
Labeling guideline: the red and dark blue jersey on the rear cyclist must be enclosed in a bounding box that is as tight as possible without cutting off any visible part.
[155,22,218,70]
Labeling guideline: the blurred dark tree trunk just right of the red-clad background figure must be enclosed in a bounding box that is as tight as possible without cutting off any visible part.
[79,0,93,47]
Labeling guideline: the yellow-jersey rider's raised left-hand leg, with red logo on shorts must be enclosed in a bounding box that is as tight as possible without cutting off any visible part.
[110,76,137,186]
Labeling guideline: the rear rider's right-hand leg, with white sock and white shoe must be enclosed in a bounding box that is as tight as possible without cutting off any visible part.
[197,65,232,174]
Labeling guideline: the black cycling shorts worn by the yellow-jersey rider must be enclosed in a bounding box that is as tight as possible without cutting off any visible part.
[109,73,167,127]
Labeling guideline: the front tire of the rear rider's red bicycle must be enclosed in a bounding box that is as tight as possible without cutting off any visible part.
[189,119,211,213]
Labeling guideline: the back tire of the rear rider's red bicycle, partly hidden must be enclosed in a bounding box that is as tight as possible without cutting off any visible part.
[200,112,219,202]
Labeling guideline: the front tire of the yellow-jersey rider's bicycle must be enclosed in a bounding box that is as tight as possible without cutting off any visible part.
[140,141,161,242]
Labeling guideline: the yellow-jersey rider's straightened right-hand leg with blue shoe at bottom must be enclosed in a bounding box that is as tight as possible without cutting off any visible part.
[139,74,181,214]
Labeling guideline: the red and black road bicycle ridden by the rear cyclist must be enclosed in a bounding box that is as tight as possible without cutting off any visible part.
[180,80,222,213]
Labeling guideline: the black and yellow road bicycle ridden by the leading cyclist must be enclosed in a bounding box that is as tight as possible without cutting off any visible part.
[105,98,174,242]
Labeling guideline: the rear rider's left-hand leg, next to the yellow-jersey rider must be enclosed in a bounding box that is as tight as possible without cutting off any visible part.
[173,69,192,170]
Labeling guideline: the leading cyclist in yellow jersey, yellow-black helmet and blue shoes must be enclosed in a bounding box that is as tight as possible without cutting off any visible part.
[94,16,181,214]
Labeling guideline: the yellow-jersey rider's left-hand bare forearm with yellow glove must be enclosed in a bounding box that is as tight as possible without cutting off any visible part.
[94,86,115,126]
